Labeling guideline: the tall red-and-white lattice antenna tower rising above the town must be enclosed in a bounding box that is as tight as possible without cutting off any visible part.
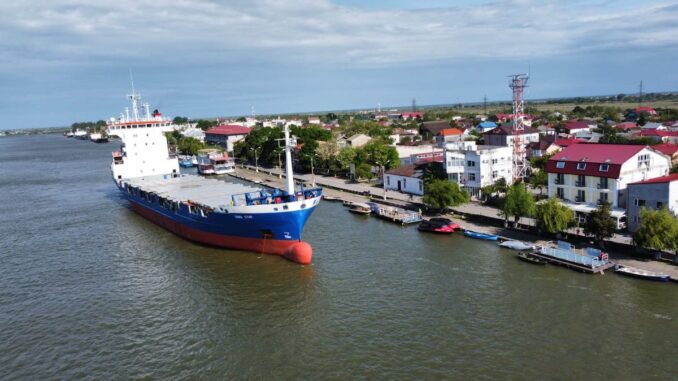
[509,74,529,181]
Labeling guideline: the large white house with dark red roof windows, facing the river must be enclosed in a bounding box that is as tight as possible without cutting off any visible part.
[546,144,671,227]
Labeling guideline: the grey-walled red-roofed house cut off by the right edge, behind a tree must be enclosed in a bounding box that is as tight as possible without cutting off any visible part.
[626,173,678,232]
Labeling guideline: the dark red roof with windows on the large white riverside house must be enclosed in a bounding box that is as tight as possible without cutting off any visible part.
[546,144,646,178]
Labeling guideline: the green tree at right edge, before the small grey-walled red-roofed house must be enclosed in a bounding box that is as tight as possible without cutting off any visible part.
[633,208,678,251]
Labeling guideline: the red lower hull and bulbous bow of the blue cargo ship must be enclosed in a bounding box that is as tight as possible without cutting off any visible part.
[131,202,313,265]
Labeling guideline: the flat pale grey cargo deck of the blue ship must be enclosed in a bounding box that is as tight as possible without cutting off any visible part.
[126,175,261,209]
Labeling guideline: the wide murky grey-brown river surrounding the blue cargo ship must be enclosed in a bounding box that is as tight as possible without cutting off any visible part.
[0,135,678,380]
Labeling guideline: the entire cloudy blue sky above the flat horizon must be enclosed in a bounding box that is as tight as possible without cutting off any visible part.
[0,0,678,129]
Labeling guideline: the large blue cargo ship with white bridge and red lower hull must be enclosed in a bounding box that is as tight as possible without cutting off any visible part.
[106,91,322,265]
